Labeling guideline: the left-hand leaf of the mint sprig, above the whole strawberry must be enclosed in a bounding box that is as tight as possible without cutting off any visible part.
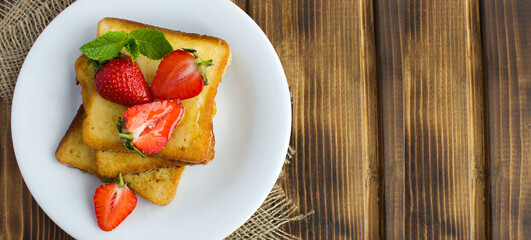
[79,31,127,62]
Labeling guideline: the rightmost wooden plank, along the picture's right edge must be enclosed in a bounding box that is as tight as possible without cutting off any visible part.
[482,0,531,239]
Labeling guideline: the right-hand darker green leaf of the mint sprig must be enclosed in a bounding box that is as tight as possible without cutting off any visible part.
[129,28,173,59]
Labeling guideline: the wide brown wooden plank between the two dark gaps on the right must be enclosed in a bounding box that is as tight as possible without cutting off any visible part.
[376,0,487,239]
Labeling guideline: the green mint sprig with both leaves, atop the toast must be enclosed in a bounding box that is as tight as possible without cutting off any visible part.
[79,28,173,62]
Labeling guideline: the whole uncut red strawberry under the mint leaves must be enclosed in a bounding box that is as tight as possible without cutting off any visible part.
[94,56,153,106]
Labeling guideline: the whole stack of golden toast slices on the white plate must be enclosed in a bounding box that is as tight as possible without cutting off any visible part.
[56,18,230,205]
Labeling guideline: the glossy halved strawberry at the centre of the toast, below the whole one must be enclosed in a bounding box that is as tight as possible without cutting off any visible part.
[118,99,184,156]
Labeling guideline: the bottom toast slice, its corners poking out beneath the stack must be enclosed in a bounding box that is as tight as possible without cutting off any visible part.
[55,107,184,205]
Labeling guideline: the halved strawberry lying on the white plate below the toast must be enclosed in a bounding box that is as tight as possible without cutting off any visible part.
[94,173,136,231]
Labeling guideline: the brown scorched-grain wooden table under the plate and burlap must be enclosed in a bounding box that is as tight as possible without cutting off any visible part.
[0,0,531,239]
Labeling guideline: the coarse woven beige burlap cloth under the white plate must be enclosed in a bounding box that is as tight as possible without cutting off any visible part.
[0,0,304,239]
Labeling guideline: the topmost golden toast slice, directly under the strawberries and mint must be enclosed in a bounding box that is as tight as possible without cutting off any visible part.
[80,18,230,164]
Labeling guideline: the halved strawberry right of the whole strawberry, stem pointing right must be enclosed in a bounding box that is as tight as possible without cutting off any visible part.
[151,49,212,100]
